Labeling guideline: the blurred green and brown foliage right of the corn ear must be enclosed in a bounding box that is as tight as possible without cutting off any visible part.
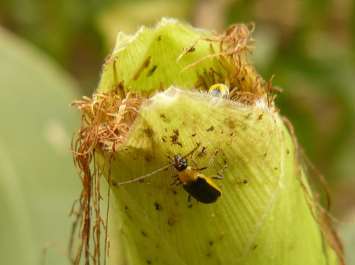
[228,0,355,184]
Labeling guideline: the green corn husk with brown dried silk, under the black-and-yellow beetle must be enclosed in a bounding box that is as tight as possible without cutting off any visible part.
[76,17,342,265]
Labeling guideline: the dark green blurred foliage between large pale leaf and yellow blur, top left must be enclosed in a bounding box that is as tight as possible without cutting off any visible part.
[0,0,112,86]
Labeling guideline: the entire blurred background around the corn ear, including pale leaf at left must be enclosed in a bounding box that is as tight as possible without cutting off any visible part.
[0,0,355,264]
